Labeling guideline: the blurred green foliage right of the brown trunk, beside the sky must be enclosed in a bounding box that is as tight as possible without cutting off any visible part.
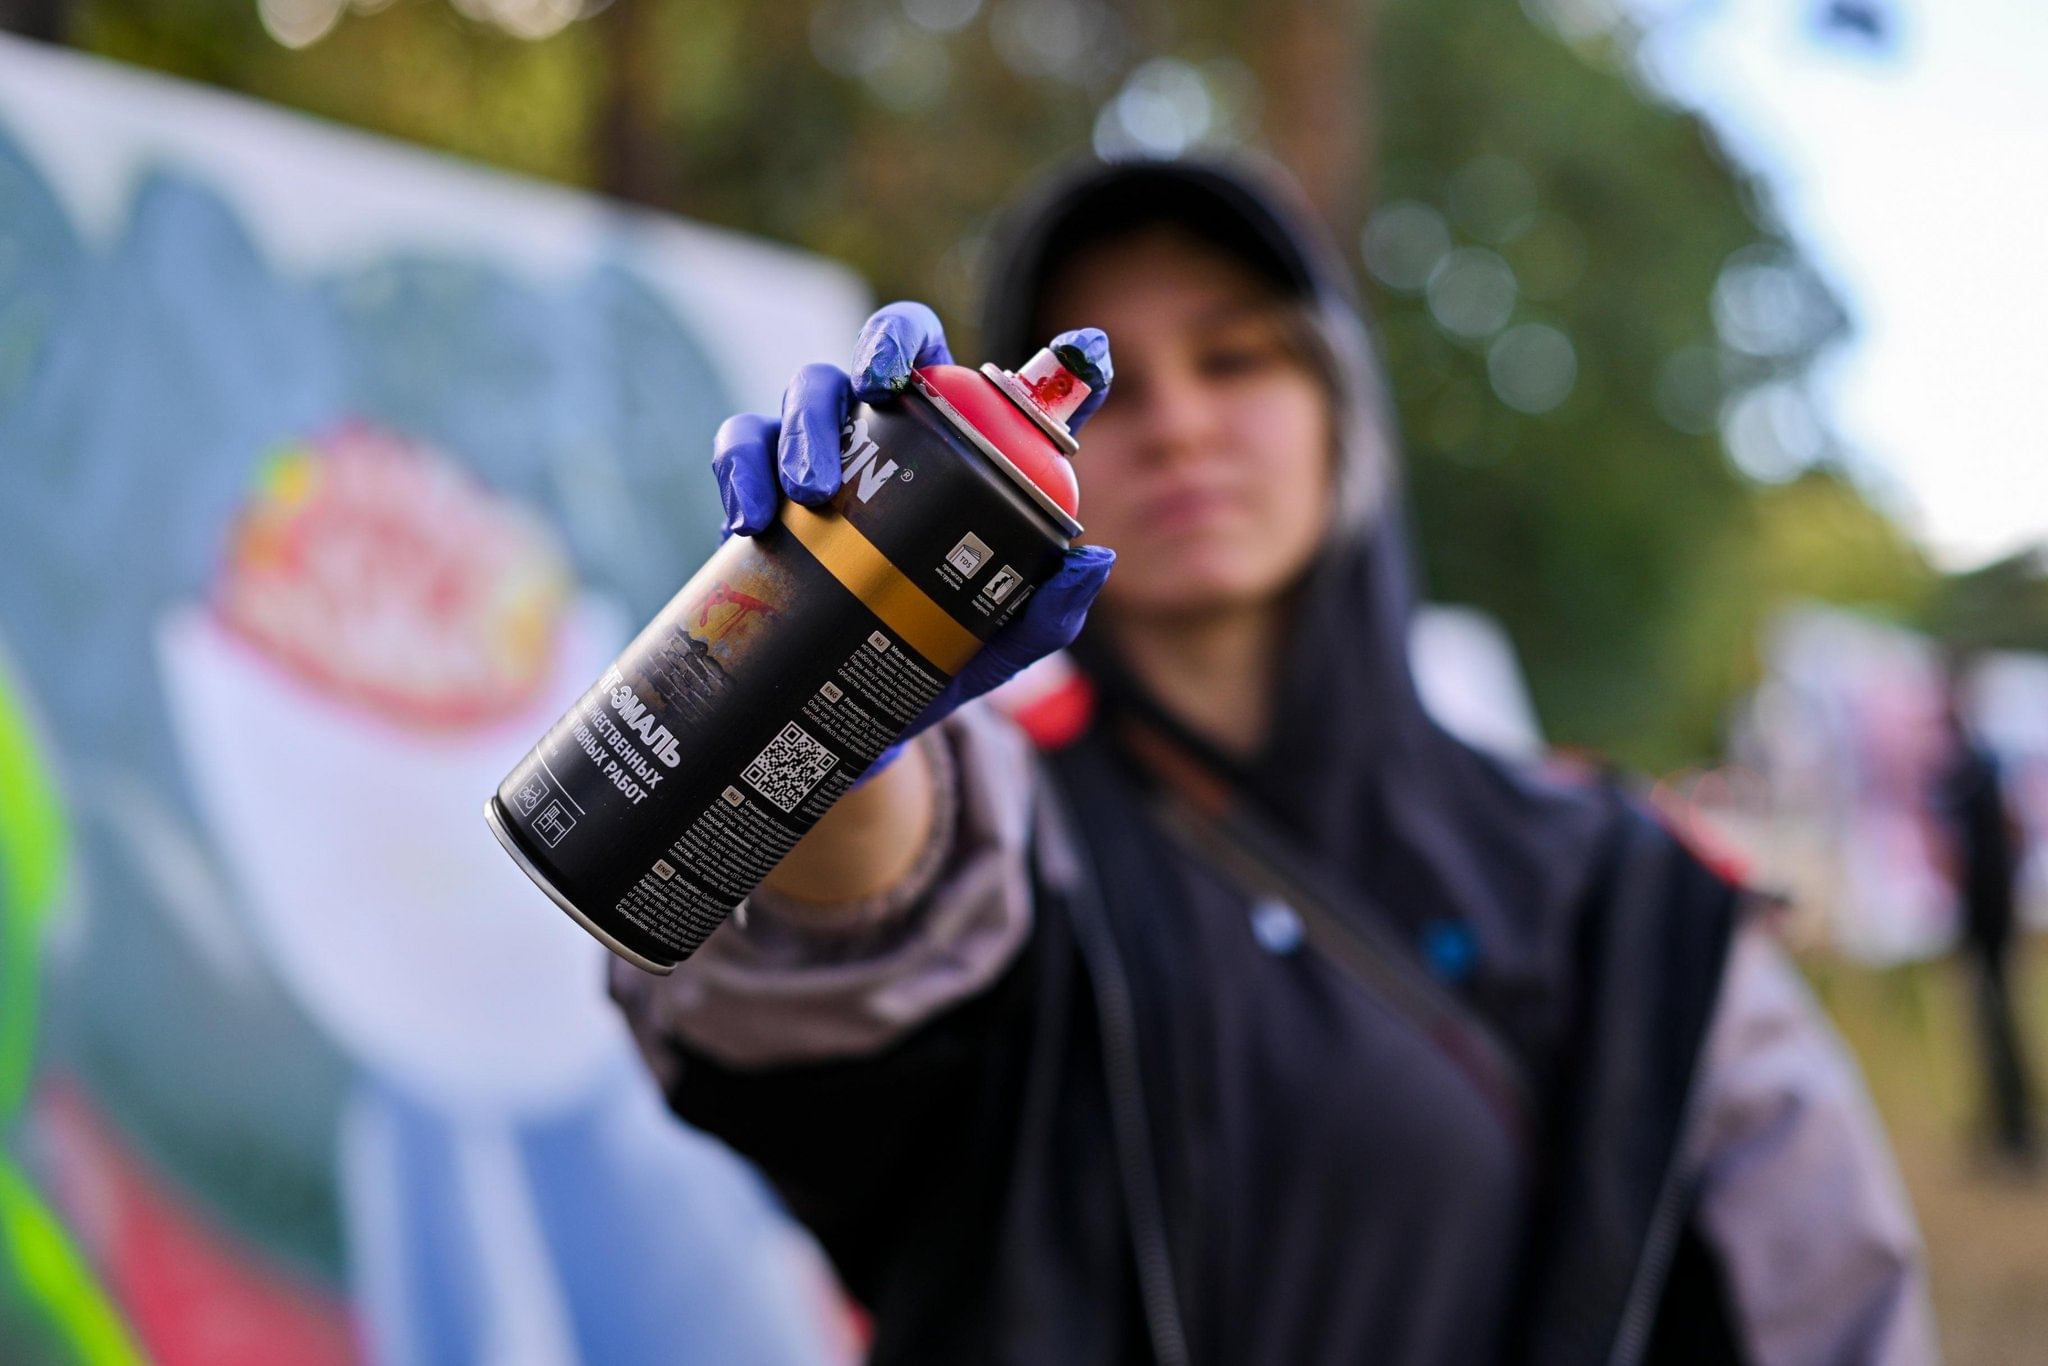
[1362,0,1911,770]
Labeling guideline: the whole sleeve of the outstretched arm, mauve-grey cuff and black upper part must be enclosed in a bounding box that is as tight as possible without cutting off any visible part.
[612,707,1053,1319]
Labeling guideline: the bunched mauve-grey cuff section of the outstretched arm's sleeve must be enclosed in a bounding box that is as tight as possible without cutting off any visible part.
[612,707,1036,1083]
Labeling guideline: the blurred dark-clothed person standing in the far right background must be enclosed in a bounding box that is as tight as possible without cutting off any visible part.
[1935,664,2040,1171]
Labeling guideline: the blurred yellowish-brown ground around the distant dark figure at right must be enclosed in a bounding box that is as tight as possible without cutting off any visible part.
[1806,936,2048,1366]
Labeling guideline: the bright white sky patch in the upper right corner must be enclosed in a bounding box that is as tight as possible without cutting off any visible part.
[1636,0,2048,569]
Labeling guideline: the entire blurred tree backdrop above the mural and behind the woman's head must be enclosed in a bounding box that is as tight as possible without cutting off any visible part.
[44,0,1925,768]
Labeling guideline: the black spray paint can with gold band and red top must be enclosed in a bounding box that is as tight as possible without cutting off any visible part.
[483,350,1090,973]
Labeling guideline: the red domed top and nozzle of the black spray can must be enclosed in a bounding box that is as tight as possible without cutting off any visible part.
[911,339,1092,537]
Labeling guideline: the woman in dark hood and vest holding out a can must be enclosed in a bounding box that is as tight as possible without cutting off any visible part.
[612,162,1933,1366]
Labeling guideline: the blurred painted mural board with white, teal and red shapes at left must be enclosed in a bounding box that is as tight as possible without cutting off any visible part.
[0,39,864,1366]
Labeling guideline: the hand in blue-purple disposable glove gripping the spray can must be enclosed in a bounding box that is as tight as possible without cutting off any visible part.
[711,303,1116,780]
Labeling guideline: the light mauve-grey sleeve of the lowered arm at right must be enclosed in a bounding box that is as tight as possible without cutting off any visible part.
[1690,924,1937,1366]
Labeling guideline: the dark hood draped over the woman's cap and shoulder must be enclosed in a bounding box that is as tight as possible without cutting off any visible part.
[983,160,1622,930]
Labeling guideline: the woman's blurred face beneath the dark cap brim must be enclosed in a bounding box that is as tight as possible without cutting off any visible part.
[1047,229,1333,618]
